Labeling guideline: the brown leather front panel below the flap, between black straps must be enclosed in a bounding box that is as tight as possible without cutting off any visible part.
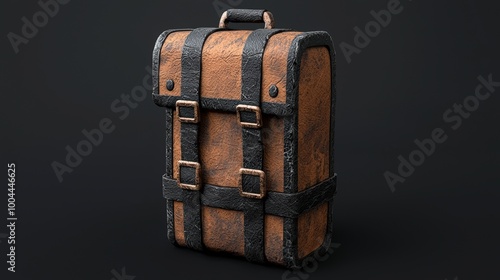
[173,110,284,263]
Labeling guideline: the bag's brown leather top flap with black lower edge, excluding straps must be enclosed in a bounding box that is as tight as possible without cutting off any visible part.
[153,30,302,113]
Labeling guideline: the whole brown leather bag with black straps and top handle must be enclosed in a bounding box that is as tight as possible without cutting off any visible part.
[153,10,336,267]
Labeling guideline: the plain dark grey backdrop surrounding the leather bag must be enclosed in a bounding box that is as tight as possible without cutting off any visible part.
[0,0,500,280]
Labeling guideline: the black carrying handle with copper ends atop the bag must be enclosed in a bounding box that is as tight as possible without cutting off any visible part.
[219,9,274,29]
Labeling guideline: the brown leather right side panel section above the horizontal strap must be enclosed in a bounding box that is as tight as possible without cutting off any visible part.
[297,47,331,191]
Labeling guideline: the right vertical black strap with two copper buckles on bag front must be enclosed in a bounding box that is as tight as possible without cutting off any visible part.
[237,29,284,262]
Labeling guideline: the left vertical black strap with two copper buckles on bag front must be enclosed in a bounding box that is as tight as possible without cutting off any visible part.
[179,28,218,250]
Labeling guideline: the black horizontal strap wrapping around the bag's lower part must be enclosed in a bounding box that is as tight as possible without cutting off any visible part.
[163,175,337,218]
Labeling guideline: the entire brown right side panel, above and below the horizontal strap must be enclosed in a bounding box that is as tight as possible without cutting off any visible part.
[297,47,332,259]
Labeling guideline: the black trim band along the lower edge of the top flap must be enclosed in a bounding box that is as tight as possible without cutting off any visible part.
[153,93,293,117]
